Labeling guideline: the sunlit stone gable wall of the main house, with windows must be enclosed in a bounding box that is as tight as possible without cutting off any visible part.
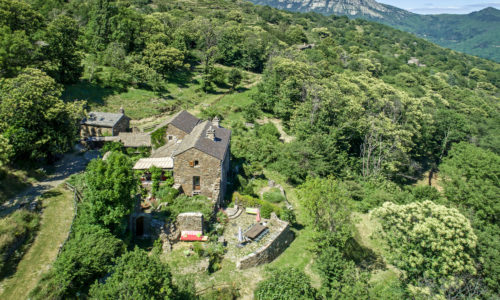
[174,148,222,201]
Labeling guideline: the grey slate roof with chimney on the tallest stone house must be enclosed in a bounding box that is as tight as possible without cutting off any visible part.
[173,121,231,160]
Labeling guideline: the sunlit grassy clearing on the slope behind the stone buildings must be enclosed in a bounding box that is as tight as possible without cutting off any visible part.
[62,68,260,120]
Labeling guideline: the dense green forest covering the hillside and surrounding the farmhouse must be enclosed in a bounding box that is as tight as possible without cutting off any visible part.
[0,0,500,299]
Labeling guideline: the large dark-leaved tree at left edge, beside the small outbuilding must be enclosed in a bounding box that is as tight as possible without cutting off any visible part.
[0,69,83,159]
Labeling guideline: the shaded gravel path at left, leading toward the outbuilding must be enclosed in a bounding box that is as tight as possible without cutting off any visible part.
[0,151,99,218]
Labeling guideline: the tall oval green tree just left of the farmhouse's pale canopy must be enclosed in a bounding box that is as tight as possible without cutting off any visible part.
[83,152,137,233]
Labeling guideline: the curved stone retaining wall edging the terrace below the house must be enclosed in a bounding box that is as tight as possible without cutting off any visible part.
[236,214,294,270]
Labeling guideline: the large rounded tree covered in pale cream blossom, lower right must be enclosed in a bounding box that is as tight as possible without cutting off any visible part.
[373,201,477,286]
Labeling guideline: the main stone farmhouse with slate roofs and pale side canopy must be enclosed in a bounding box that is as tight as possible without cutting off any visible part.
[134,111,231,205]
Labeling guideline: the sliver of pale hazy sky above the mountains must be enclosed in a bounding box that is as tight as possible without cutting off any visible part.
[377,0,500,14]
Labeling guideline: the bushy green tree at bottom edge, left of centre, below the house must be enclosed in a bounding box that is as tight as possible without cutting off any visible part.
[90,247,176,299]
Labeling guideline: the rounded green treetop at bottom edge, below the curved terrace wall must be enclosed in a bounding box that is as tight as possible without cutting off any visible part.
[254,268,316,300]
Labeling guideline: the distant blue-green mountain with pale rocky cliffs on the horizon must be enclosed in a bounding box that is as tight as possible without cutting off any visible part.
[250,0,500,62]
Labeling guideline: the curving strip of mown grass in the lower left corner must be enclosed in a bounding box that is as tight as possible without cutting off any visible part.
[0,187,73,300]
